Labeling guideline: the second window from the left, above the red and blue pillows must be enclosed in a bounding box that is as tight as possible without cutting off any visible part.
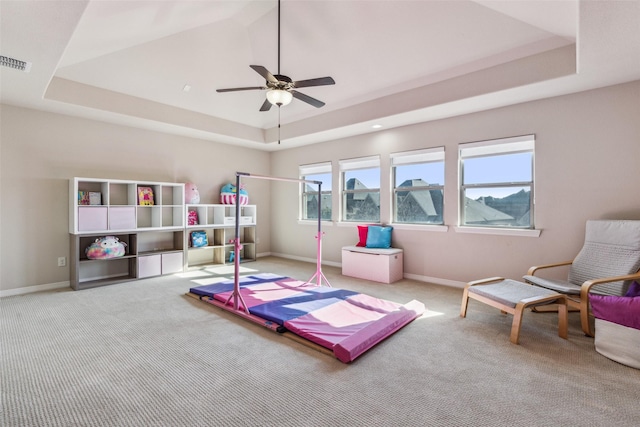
[340,156,380,222]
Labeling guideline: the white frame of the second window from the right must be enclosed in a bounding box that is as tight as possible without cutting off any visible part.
[390,147,444,225]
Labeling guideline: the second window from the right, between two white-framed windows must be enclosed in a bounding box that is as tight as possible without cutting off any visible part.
[391,147,444,224]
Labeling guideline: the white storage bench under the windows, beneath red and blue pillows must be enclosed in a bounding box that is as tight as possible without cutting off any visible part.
[342,246,404,283]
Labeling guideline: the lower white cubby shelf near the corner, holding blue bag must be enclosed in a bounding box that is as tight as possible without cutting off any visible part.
[184,204,257,268]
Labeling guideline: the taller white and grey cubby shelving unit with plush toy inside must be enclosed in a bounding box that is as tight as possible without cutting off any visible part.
[69,178,185,290]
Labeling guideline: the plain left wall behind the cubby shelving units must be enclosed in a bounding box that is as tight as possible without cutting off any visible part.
[0,105,271,291]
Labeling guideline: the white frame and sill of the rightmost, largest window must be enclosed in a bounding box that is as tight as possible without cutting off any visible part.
[457,135,539,232]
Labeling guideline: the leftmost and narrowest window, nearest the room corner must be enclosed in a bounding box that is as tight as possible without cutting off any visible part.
[300,162,331,221]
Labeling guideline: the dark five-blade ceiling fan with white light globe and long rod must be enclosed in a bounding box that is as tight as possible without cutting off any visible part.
[216,0,336,111]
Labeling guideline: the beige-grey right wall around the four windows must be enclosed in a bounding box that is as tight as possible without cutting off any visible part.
[271,81,640,284]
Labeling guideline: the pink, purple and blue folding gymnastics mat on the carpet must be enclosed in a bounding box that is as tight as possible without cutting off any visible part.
[190,273,425,363]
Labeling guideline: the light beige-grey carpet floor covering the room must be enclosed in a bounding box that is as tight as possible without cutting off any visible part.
[0,257,640,427]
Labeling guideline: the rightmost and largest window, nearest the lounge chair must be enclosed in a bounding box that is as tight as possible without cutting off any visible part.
[460,135,535,228]
